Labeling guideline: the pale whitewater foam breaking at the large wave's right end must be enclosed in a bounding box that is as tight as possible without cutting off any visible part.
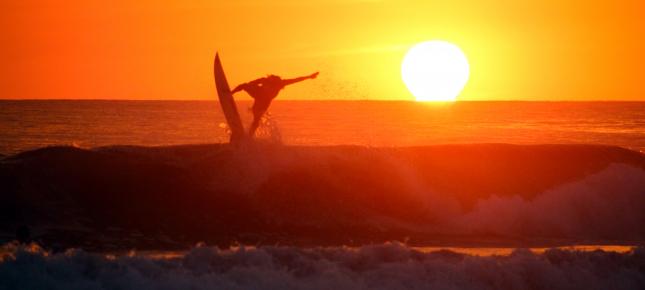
[452,164,645,240]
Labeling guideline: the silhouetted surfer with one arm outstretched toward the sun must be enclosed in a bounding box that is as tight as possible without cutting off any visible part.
[231,72,318,137]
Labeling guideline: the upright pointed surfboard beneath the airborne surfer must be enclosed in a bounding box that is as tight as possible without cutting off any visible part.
[213,53,246,143]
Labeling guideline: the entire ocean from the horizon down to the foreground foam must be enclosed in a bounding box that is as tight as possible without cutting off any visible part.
[0,101,645,290]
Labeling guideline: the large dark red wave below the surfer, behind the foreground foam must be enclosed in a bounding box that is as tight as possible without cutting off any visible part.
[0,144,645,250]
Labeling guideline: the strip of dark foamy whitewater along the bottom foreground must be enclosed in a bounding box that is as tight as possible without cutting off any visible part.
[0,243,645,290]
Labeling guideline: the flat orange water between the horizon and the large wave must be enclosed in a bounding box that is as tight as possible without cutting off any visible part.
[0,100,645,154]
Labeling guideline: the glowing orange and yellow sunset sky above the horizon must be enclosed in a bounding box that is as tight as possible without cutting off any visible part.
[0,0,645,100]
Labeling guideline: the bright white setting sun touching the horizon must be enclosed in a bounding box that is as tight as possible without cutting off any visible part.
[401,40,470,101]
